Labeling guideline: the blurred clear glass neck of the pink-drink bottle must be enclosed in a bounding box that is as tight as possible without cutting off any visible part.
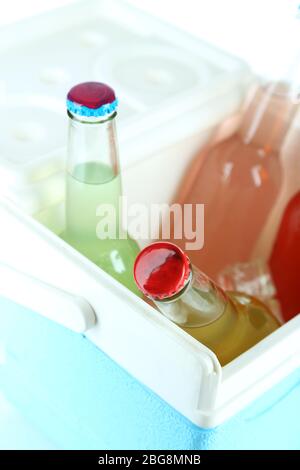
[240,82,298,154]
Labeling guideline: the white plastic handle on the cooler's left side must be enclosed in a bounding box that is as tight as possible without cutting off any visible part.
[0,263,96,333]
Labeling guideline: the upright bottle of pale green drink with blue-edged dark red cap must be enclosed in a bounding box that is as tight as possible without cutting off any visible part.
[63,82,140,295]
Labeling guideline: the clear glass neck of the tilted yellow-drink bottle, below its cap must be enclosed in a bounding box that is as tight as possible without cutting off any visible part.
[154,266,228,327]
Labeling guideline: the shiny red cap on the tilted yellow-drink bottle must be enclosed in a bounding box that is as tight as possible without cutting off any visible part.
[134,242,191,300]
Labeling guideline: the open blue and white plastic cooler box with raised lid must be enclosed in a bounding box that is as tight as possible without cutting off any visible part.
[0,0,300,450]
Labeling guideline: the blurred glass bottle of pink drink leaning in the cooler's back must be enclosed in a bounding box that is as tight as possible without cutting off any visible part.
[175,74,298,279]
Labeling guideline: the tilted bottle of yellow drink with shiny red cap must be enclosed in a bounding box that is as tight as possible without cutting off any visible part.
[134,242,280,365]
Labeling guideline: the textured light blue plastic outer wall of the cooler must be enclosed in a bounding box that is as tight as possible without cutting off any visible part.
[0,299,300,450]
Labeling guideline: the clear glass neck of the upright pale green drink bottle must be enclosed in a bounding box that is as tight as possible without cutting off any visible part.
[67,112,120,184]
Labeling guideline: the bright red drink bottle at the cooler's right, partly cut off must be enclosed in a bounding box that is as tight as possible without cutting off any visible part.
[269,191,300,320]
